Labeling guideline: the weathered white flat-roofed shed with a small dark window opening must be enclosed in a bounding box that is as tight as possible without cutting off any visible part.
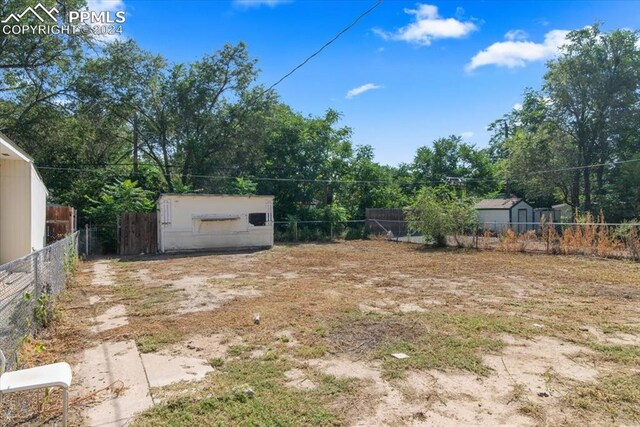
[158,194,273,252]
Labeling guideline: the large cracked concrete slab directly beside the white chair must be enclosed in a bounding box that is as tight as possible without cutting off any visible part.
[74,341,153,427]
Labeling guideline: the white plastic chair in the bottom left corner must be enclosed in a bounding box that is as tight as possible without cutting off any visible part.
[0,350,71,427]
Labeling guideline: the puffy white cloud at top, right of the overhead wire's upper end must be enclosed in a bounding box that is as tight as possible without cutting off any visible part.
[373,3,478,46]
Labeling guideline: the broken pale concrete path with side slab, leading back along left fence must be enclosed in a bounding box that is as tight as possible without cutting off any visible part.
[72,261,213,427]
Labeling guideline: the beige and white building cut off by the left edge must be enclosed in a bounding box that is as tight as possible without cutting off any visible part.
[0,133,49,264]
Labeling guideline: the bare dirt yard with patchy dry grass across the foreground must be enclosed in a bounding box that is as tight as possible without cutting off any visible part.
[6,240,640,426]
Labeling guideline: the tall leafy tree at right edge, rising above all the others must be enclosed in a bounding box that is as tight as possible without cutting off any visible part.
[544,24,640,211]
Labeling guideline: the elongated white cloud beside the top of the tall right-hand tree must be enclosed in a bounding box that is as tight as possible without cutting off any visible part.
[466,30,569,71]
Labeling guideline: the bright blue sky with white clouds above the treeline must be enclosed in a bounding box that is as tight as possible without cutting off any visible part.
[101,0,640,165]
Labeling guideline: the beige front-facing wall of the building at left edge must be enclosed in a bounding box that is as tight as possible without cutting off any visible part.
[0,159,31,264]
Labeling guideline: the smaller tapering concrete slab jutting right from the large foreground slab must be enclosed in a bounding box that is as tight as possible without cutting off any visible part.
[142,353,213,387]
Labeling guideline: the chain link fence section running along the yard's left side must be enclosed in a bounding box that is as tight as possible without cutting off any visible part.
[0,232,80,370]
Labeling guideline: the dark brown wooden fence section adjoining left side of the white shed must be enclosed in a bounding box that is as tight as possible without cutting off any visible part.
[118,212,158,255]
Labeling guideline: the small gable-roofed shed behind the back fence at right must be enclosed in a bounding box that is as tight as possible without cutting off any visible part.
[475,197,534,233]
